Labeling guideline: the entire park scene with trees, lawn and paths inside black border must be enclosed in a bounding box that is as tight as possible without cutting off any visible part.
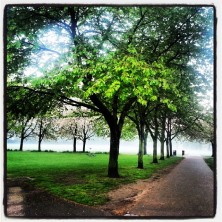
[4,5,216,218]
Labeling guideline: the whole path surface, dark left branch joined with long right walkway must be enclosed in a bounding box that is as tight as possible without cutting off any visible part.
[7,157,214,218]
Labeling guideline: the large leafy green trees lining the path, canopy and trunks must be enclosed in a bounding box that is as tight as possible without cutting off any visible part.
[5,5,214,177]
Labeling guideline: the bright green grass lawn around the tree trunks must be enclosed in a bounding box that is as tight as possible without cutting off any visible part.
[7,151,181,205]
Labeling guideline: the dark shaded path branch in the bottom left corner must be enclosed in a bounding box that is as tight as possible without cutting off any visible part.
[5,180,111,219]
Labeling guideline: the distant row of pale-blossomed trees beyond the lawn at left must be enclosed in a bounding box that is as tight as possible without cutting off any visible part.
[7,109,95,152]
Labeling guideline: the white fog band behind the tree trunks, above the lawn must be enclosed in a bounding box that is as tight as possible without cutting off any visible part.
[7,138,212,156]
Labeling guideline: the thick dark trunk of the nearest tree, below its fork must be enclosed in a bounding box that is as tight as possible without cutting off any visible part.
[108,127,120,178]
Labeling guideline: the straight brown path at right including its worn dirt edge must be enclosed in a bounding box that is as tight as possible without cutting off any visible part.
[99,157,214,217]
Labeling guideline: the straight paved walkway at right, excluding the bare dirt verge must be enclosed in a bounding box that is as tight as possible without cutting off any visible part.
[128,157,216,217]
